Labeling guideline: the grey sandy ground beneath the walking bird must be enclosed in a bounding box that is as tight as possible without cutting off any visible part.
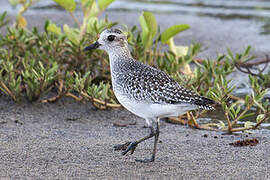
[0,97,270,180]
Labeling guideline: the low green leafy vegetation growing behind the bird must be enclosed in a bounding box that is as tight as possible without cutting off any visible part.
[0,0,270,133]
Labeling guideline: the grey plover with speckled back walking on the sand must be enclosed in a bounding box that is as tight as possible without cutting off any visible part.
[84,28,215,162]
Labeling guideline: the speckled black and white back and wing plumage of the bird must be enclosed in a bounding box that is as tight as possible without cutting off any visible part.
[112,58,214,110]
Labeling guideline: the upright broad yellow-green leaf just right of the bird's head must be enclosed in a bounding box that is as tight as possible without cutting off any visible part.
[139,12,158,49]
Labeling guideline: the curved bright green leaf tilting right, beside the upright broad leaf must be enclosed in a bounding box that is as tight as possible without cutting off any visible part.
[161,24,190,44]
